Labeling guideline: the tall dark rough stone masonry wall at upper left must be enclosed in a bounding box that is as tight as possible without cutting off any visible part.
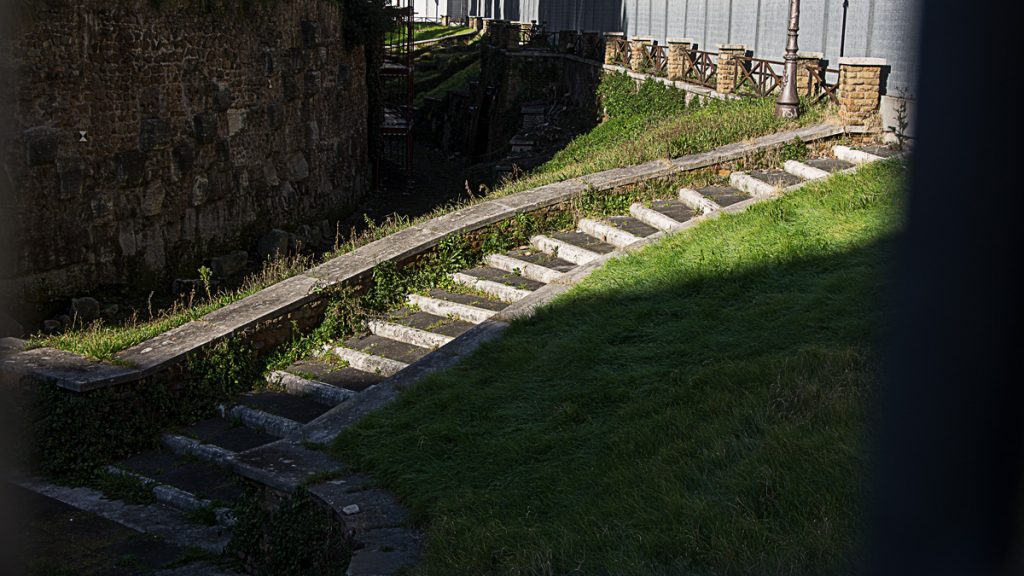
[0,0,369,298]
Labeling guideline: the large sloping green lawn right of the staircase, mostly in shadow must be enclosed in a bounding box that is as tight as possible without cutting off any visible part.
[332,157,905,575]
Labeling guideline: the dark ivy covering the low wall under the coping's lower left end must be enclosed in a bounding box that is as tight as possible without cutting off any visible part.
[26,339,262,484]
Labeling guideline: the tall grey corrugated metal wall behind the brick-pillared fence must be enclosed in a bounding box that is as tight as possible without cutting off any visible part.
[471,0,921,93]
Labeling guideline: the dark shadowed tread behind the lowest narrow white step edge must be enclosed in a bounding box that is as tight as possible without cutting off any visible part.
[115,450,243,504]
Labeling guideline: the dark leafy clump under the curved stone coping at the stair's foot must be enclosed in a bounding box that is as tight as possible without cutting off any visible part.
[226,489,351,576]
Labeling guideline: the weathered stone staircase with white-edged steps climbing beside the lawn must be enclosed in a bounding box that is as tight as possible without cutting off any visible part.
[18,141,896,576]
